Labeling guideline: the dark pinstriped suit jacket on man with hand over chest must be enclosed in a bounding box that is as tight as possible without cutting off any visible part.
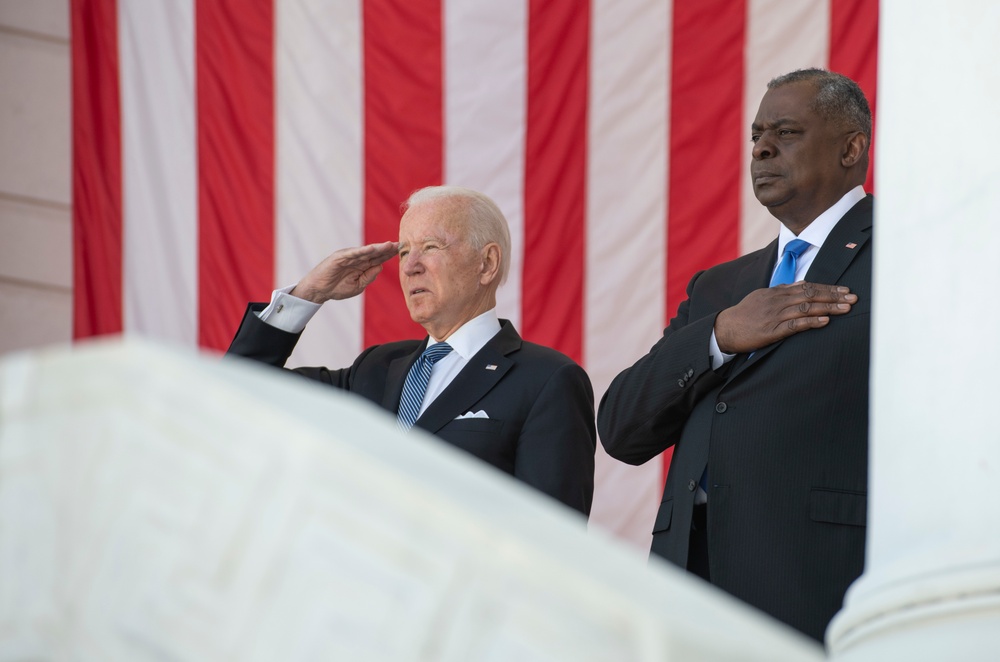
[598,196,873,640]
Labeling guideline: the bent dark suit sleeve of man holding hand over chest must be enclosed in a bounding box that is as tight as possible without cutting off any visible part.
[597,274,729,465]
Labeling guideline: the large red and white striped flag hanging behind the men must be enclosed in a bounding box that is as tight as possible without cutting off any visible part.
[72,0,878,547]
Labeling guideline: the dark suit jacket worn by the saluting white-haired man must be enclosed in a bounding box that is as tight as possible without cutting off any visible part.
[227,304,596,515]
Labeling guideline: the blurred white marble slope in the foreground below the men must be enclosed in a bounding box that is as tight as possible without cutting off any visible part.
[0,340,824,662]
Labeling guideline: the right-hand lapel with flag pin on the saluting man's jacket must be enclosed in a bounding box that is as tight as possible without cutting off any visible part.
[416,320,521,432]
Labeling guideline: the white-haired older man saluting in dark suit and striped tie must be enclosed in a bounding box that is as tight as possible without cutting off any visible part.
[228,186,596,515]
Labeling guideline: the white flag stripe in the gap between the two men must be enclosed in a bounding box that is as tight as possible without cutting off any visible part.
[584,0,671,549]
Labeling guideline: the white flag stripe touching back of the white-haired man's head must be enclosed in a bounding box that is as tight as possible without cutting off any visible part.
[444,2,528,329]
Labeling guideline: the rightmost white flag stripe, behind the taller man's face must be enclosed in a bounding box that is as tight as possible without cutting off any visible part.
[740,0,830,253]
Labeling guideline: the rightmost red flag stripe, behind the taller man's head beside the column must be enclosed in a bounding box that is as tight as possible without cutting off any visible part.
[830,0,878,193]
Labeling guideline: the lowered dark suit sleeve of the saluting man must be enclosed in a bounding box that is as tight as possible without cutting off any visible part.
[514,363,597,515]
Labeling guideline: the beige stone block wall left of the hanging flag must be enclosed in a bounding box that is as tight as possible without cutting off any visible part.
[0,0,72,354]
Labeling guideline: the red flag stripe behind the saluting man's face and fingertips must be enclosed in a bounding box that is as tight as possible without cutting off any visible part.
[363,0,444,347]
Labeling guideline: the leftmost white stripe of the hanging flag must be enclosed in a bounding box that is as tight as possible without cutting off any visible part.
[118,1,198,346]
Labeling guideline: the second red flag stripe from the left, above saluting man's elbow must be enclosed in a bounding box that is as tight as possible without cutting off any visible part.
[195,0,274,349]
